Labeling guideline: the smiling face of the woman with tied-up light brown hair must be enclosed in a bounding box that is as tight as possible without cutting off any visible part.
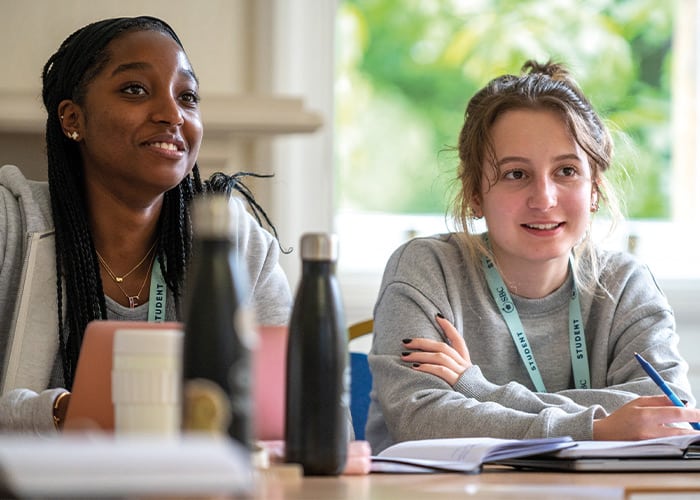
[473,109,595,280]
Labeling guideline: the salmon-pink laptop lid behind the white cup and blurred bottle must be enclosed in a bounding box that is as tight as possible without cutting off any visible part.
[64,321,287,440]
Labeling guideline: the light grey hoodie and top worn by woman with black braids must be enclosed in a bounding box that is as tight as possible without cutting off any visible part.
[0,165,292,432]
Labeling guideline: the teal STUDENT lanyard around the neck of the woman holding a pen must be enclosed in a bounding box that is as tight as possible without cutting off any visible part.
[482,256,591,392]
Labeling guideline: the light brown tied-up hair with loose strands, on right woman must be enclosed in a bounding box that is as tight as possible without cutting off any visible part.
[452,60,621,291]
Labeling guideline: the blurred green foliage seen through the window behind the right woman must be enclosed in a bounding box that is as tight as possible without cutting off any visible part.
[336,0,674,218]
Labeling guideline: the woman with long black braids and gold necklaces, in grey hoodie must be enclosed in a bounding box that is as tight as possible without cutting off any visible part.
[0,16,291,432]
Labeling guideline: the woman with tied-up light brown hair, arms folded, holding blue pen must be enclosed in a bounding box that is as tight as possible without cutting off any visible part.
[367,61,700,453]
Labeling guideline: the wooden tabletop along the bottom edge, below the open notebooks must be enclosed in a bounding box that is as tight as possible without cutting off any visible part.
[251,466,700,500]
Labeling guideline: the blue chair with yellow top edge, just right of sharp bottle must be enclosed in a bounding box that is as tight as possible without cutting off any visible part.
[348,319,374,440]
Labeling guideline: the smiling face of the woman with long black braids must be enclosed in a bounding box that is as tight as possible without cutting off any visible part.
[64,31,202,202]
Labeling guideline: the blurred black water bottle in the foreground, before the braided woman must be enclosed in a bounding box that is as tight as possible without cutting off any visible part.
[183,195,257,448]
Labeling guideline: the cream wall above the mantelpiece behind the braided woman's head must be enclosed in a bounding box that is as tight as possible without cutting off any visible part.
[0,0,251,93]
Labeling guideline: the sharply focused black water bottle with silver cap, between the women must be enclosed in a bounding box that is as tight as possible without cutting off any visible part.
[285,234,349,475]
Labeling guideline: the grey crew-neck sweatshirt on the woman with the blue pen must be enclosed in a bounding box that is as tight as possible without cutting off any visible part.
[366,235,694,454]
